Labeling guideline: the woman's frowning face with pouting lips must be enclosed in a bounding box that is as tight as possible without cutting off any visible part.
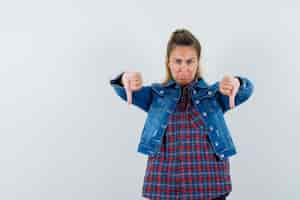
[168,46,198,85]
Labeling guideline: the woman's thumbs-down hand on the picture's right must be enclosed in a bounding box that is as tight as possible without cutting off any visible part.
[219,75,240,109]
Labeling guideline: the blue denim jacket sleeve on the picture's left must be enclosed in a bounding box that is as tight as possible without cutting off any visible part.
[110,72,152,112]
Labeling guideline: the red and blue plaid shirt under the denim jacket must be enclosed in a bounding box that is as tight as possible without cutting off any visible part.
[142,81,232,200]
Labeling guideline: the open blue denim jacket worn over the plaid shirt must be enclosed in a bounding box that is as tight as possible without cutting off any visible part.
[110,72,254,160]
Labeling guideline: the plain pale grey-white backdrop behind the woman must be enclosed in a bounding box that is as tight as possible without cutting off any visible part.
[0,0,300,200]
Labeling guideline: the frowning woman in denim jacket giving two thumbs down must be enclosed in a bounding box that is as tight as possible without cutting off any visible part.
[110,29,253,200]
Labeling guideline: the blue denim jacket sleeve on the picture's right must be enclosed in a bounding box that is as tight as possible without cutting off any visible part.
[217,76,254,113]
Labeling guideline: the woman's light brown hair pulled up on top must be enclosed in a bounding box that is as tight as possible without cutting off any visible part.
[162,28,202,84]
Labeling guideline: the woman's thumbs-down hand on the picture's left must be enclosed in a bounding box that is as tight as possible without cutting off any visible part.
[122,72,143,104]
